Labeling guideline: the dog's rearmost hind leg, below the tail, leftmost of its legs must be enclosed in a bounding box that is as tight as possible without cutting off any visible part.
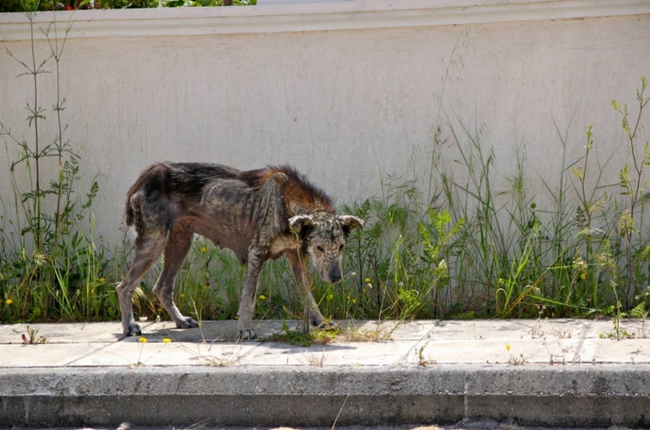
[117,235,165,336]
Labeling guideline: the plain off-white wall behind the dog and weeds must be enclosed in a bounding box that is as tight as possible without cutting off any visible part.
[0,0,650,247]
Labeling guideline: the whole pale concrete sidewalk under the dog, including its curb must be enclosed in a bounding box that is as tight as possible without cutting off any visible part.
[0,320,650,428]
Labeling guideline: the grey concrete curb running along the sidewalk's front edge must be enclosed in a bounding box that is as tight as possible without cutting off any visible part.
[0,364,650,428]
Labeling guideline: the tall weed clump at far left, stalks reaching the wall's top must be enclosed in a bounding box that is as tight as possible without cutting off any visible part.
[0,5,115,320]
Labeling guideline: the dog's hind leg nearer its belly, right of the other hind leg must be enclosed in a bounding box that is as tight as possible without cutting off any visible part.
[153,223,199,328]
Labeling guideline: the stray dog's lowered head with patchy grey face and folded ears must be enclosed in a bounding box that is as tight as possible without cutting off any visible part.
[289,212,363,283]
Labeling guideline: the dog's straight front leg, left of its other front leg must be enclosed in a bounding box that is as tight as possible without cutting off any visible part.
[237,245,267,340]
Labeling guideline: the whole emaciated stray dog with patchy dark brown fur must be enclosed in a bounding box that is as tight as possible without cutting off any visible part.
[117,163,364,339]
